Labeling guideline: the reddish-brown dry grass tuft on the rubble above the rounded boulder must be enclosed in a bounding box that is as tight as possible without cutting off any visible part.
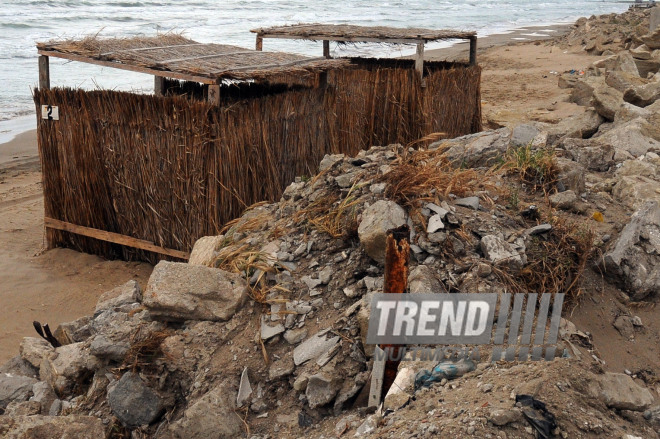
[382,150,496,208]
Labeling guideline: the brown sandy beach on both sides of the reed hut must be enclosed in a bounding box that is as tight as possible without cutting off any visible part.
[0,25,620,363]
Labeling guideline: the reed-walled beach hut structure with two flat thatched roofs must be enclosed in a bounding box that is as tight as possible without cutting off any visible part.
[34,25,481,262]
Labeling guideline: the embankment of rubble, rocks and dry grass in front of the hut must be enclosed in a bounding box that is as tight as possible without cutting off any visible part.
[0,6,660,439]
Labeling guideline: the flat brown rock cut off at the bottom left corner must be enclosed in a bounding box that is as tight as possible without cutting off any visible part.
[0,415,106,439]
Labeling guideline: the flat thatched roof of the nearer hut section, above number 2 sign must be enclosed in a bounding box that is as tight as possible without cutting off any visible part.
[37,34,346,84]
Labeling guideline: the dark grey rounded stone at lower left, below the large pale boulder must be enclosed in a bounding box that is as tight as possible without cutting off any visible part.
[108,372,164,428]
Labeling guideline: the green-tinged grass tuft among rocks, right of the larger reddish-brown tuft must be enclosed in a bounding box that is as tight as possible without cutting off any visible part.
[499,145,559,191]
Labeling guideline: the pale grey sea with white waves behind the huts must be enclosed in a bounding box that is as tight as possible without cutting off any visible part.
[0,0,627,135]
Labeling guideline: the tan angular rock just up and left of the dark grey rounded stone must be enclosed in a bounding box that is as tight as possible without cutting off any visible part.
[39,342,102,396]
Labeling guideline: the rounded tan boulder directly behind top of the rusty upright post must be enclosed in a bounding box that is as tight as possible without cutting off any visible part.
[358,200,408,262]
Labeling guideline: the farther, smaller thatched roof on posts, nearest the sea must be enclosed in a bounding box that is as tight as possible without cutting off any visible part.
[251,23,477,43]
